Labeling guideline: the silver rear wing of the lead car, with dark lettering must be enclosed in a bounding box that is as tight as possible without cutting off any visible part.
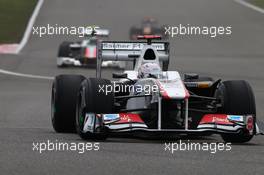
[97,41,169,77]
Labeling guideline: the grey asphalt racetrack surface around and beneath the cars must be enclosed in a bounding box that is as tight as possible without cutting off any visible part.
[0,0,264,175]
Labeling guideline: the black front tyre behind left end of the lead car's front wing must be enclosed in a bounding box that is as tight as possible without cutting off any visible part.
[76,78,114,140]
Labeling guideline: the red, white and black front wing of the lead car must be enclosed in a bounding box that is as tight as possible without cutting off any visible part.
[83,113,261,135]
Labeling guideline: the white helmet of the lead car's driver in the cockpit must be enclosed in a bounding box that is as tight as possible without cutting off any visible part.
[138,63,162,78]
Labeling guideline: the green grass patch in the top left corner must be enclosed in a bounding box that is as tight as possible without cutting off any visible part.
[0,0,37,43]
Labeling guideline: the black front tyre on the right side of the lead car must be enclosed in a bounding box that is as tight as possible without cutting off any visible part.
[216,80,256,143]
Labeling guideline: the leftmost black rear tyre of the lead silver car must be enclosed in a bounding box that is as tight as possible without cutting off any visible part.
[51,75,85,132]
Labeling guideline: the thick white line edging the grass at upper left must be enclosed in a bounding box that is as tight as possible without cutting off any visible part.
[15,0,44,54]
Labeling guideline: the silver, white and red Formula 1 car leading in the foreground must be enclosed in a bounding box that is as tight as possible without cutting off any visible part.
[52,35,261,143]
